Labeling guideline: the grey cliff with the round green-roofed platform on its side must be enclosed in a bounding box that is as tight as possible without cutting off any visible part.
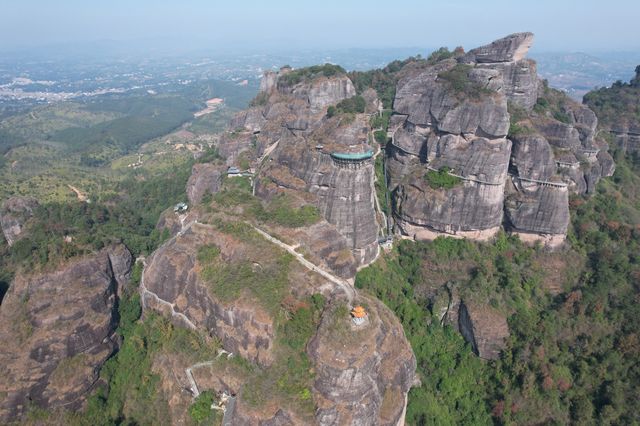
[228,69,378,276]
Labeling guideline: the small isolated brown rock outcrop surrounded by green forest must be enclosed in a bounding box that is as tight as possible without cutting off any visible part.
[458,303,509,359]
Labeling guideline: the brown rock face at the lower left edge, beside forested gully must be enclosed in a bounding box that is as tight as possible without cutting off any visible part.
[0,245,132,422]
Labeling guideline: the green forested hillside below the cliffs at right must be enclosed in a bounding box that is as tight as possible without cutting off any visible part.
[356,68,640,425]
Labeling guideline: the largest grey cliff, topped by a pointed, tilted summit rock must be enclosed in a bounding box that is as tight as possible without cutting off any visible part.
[386,33,614,247]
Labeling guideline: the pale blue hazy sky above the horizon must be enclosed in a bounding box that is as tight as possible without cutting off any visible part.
[0,0,640,51]
